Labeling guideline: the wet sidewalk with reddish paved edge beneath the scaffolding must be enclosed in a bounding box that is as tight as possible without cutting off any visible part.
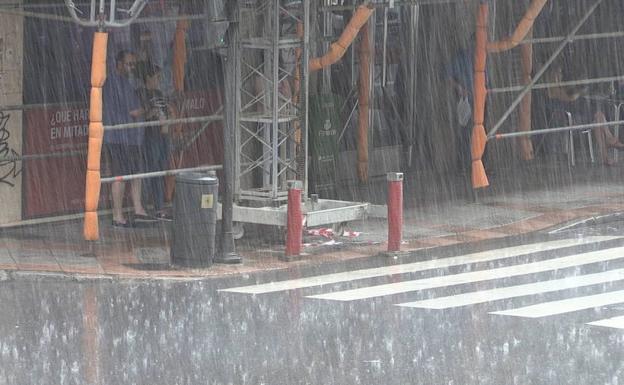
[0,162,624,279]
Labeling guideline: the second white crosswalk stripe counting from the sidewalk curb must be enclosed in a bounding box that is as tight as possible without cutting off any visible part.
[308,247,624,301]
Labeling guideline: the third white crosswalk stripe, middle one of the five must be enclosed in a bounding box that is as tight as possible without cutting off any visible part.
[397,269,624,310]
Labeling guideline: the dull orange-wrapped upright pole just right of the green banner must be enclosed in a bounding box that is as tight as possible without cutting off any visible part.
[357,22,371,182]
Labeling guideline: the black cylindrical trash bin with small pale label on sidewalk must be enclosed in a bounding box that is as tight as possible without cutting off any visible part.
[171,172,219,267]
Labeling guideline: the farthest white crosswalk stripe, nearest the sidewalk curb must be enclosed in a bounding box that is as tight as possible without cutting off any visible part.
[219,236,620,294]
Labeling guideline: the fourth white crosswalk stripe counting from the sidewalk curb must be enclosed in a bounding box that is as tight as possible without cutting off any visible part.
[490,290,624,318]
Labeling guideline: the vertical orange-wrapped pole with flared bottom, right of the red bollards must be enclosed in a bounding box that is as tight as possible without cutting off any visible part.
[470,3,490,189]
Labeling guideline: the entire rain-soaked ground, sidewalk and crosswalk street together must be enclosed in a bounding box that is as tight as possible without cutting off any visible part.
[0,162,624,385]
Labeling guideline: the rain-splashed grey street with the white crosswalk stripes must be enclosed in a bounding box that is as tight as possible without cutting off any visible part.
[0,223,624,385]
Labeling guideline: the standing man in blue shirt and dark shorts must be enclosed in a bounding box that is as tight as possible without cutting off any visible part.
[102,51,151,227]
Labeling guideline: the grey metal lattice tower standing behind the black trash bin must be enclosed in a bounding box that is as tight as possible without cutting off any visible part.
[234,0,310,201]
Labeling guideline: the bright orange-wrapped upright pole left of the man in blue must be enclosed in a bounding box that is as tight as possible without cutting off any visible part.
[83,32,108,241]
